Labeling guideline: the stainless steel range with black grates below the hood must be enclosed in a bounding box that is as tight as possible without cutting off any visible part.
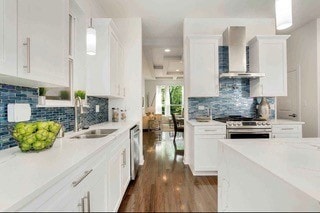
[214,116,271,139]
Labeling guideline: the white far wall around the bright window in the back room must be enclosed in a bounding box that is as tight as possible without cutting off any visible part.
[145,79,184,111]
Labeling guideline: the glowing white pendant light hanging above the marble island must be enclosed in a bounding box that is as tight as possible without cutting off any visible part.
[275,0,292,30]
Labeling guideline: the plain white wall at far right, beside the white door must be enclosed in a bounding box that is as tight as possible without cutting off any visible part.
[287,20,320,137]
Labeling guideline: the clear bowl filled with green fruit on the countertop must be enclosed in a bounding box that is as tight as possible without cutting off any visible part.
[10,121,61,152]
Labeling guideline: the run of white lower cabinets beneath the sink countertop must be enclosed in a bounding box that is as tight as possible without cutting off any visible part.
[17,131,130,212]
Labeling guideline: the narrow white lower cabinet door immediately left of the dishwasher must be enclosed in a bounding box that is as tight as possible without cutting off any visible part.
[121,139,130,194]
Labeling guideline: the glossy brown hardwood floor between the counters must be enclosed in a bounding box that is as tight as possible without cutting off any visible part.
[119,132,217,212]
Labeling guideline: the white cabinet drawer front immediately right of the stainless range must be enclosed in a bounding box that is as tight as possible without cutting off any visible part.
[272,124,302,138]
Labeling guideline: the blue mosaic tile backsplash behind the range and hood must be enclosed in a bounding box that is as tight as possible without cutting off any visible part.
[188,46,275,119]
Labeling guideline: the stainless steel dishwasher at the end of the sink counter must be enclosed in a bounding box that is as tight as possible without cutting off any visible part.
[130,125,140,180]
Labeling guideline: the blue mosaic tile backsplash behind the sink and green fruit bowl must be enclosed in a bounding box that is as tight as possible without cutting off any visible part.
[0,84,108,150]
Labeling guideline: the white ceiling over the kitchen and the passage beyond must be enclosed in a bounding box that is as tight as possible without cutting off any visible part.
[96,0,320,79]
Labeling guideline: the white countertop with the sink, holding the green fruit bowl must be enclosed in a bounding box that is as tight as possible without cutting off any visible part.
[0,121,138,211]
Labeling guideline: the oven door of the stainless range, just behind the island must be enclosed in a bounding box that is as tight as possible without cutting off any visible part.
[227,129,271,139]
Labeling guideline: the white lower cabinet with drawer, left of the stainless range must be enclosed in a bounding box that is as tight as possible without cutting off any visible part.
[189,126,226,175]
